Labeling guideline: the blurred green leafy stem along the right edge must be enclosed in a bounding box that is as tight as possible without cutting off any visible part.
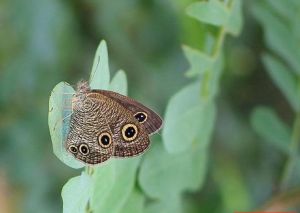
[251,0,300,190]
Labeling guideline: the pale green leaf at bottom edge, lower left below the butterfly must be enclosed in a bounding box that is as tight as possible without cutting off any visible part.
[61,172,93,213]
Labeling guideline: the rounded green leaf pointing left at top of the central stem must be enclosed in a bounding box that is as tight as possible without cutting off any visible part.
[186,1,229,26]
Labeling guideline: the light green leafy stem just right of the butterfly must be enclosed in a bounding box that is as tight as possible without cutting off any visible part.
[149,0,242,212]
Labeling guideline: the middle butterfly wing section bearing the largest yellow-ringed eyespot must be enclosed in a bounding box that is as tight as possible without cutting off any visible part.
[88,92,150,157]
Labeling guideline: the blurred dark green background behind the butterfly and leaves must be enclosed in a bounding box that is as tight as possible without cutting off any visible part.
[0,0,300,212]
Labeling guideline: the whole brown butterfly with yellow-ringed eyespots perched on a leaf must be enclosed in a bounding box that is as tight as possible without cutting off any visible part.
[66,81,162,164]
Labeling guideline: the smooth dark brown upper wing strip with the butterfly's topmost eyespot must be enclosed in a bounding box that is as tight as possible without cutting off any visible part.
[93,90,162,134]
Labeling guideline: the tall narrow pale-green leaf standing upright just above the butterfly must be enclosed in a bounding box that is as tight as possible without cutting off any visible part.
[89,41,110,90]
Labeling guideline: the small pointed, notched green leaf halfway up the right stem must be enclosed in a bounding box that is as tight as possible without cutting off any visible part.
[182,45,214,77]
